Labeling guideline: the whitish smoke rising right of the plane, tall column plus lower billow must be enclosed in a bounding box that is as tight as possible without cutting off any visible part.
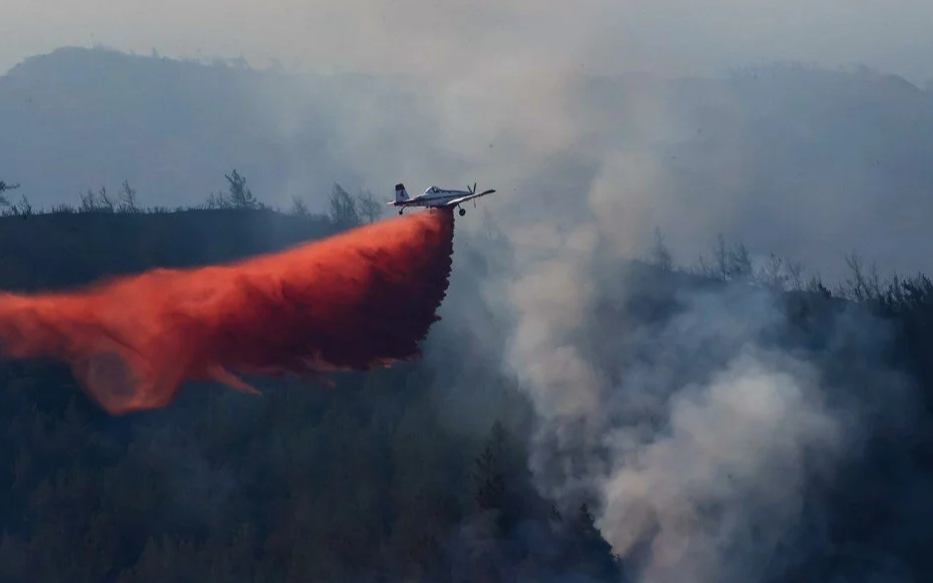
[499,165,872,583]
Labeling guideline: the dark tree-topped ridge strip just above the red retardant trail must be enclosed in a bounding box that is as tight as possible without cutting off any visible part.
[0,170,382,291]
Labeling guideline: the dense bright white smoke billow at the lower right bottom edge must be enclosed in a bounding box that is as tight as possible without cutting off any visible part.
[600,354,845,583]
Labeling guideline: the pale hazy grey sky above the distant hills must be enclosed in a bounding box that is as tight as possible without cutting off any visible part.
[0,0,933,83]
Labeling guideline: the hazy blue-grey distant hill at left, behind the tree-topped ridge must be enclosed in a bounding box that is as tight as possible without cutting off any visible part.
[0,48,402,212]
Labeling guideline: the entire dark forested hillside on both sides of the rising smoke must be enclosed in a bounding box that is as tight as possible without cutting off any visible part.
[0,175,933,583]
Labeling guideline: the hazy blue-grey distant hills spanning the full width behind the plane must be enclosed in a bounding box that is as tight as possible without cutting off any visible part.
[0,48,933,276]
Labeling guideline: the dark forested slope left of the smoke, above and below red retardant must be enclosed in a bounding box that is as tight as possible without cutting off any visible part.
[0,186,618,582]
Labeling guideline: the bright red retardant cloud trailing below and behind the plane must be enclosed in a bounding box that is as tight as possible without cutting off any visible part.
[0,209,454,415]
